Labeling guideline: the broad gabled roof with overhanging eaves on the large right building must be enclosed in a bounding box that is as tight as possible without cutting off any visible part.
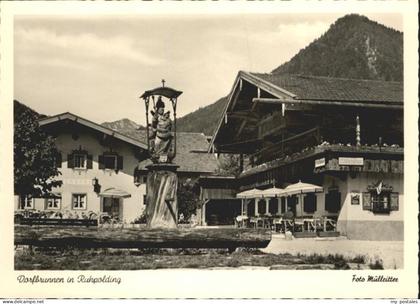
[208,71,404,153]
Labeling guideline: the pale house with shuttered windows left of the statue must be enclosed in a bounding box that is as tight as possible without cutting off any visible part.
[15,113,146,223]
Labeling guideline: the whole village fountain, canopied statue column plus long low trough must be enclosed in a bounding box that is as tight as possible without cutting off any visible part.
[14,80,271,252]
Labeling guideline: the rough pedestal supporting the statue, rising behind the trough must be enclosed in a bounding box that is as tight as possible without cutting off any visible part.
[146,163,179,228]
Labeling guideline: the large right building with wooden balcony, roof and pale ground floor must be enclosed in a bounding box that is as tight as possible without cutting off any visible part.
[209,71,404,240]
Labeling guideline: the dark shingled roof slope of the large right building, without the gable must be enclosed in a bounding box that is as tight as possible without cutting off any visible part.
[250,73,404,103]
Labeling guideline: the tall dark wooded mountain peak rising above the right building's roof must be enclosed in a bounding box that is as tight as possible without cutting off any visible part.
[272,14,403,81]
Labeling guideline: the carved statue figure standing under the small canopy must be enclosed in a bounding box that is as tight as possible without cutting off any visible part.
[150,96,173,163]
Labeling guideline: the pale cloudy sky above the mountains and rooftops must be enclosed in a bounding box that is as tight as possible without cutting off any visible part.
[14,14,403,125]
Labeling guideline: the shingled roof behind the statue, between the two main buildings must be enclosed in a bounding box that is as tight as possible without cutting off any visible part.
[101,122,218,173]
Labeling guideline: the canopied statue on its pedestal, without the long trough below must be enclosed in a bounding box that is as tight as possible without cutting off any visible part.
[140,80,182,228]
